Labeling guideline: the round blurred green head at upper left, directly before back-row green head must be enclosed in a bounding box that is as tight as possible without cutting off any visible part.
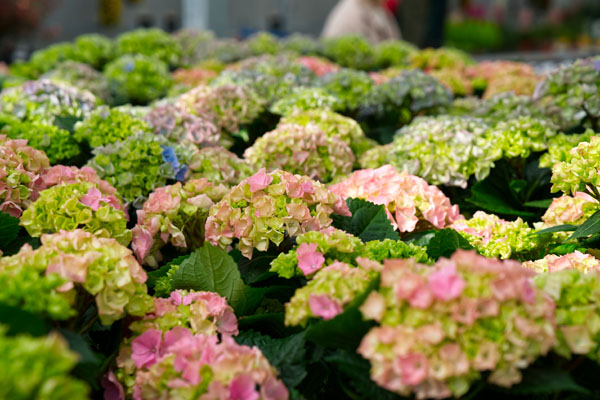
[104,54,173,104]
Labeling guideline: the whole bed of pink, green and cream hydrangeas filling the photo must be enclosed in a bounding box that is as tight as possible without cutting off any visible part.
[0,26,600,400]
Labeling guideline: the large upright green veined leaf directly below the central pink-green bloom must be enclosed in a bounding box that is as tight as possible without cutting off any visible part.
[173,243,251,313]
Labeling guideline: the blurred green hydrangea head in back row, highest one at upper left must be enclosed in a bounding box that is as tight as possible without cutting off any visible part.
[115,28,182,67]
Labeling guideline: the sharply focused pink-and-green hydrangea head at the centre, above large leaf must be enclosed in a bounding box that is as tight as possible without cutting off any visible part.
[206,169,350,258]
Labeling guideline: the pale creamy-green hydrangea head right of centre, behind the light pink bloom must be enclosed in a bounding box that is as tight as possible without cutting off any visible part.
[360,116,502,187]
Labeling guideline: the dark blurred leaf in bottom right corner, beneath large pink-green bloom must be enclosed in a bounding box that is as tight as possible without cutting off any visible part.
[507,366,589,398]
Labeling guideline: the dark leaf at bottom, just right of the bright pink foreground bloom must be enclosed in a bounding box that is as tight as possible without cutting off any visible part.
[235,331,307,388]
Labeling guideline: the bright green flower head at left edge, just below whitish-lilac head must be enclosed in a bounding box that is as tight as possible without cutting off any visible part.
[0,117,80,164]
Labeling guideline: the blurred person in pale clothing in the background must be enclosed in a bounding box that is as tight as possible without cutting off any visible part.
[322,0,400,43]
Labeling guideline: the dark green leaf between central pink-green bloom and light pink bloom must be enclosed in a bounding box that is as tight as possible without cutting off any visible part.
[332,199,400,242]
